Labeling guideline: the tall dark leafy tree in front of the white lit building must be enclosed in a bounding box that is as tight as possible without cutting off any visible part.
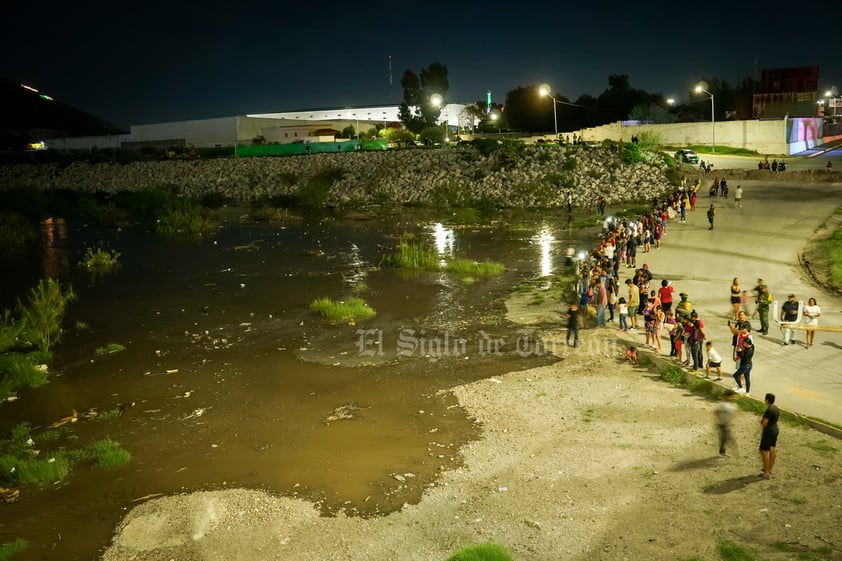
[398,62,450,134]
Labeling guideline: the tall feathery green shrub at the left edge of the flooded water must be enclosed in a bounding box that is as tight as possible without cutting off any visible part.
[18,279,76,352]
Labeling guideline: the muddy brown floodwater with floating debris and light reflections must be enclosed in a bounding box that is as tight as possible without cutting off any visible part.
[0,213,568,561]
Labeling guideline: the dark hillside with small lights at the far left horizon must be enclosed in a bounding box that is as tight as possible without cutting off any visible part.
[0,78,125,151]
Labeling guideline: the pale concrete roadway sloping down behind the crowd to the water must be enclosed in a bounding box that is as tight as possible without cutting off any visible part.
[609,178,842,425]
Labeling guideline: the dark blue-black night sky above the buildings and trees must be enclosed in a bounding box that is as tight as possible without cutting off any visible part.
[0,0,842,127]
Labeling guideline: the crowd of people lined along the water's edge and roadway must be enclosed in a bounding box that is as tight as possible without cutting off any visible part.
[565,185,821,395]
